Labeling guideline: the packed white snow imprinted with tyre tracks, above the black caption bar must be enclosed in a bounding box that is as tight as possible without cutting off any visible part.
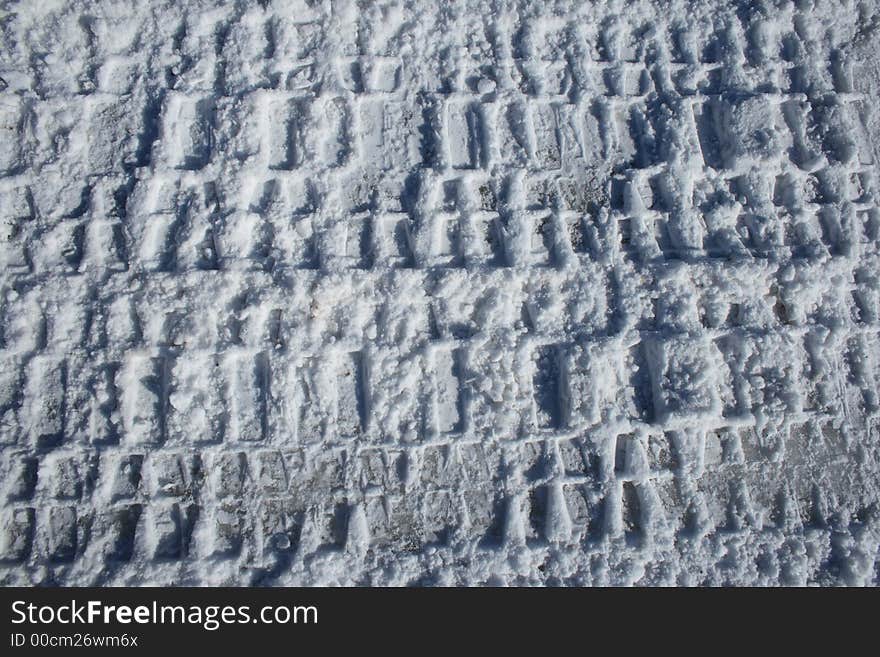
[0,0,880,585]
